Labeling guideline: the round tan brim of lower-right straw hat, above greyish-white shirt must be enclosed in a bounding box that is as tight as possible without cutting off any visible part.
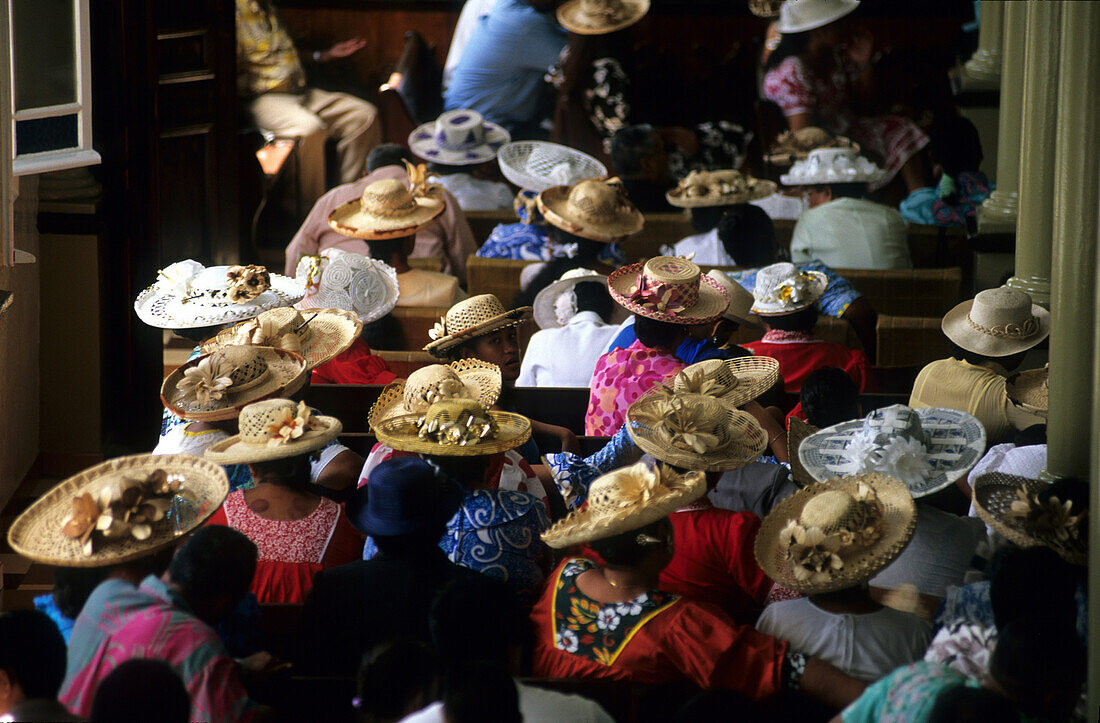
[754,474,916,595]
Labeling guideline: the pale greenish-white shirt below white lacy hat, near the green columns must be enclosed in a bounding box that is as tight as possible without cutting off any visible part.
[792,198,913,269]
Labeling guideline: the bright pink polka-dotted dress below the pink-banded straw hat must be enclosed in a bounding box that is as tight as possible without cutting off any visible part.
[584,340,686,437]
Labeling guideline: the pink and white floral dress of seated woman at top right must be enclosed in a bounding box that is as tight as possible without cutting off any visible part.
[763,55,928,190]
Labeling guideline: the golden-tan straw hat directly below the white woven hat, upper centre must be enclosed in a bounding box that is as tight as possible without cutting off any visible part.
[537,178,646,243]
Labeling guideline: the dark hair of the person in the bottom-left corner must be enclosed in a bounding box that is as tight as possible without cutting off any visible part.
[0,610,66,698]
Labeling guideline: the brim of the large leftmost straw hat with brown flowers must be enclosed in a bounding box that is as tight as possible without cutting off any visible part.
[8,454,229,568]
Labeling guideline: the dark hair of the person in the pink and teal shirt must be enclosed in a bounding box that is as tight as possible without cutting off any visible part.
[168,525,257,603]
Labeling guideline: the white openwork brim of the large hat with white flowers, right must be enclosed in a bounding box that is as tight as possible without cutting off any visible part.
[799,407,986,497]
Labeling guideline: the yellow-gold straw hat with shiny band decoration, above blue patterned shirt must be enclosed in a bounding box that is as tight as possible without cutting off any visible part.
[372,398,531,457]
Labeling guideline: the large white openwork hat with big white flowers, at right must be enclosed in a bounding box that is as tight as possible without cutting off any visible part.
[799,404,986,497]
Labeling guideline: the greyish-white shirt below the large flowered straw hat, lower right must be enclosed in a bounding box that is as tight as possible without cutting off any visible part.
[756,598,932,681]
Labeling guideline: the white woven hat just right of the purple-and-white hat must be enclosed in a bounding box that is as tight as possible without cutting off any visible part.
[496,141,607,193]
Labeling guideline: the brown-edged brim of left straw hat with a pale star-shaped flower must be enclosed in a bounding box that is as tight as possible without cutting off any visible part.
[161,347,309,421]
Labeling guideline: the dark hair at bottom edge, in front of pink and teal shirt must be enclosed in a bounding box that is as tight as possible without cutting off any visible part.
[90,658,191,723]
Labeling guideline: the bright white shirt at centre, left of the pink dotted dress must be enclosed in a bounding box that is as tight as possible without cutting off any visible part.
[516,311,619,387]
